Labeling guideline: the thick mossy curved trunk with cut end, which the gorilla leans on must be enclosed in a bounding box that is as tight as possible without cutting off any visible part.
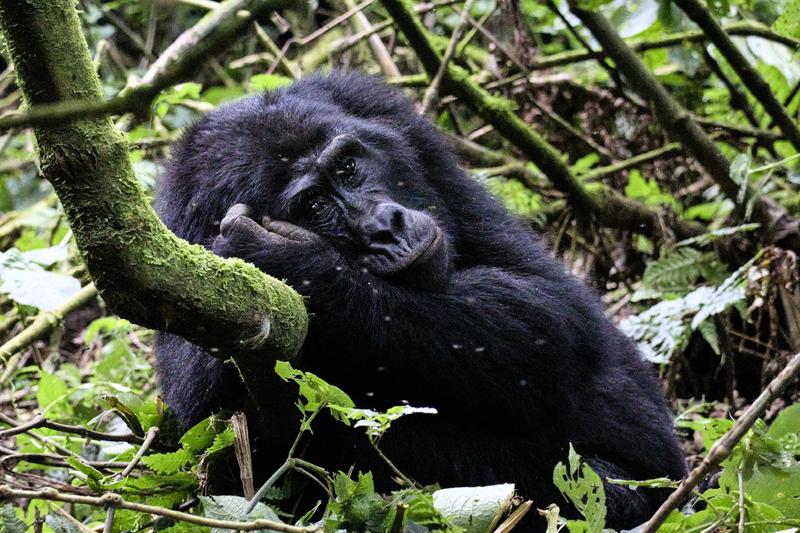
[0,0,308,412]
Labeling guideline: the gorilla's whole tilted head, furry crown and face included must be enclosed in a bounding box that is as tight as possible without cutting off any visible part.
[158,77,448,279]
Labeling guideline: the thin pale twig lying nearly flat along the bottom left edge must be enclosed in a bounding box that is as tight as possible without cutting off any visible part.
[0,485,322,533]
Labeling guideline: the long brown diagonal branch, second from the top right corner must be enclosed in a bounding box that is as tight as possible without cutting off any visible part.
[570,0,800,251]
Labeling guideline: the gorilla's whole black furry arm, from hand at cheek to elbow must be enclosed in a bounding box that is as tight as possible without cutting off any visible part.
[209,206,683,523]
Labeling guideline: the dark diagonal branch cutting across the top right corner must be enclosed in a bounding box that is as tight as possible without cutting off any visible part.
[675,0,800,151]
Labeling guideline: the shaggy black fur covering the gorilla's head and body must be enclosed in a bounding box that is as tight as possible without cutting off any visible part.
[157,73,685,528]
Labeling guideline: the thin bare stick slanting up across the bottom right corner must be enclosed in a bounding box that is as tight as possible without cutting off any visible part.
[641,353,800,533]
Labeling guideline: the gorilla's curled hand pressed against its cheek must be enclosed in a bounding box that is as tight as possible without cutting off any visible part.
[211,204,340,288]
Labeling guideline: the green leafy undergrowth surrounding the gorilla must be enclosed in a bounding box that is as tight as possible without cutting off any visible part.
[0,0,800,533]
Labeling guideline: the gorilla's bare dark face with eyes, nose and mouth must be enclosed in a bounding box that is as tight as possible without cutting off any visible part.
[270,133,447,278]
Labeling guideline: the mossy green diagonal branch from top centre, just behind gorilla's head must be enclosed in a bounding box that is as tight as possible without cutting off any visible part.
[382,0,703,237]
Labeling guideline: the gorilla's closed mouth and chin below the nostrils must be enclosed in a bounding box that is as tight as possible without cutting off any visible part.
[360,225,444,278]
